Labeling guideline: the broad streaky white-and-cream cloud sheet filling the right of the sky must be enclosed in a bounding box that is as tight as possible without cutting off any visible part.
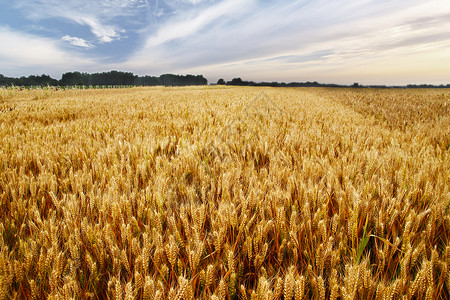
[125,0,450,83]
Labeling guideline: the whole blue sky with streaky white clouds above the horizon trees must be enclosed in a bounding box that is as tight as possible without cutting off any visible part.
[0,0,450,84]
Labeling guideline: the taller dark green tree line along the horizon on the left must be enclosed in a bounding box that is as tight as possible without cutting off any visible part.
[0,71,208,86]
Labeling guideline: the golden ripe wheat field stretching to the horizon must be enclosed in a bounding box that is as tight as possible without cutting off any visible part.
[0,86,450,300]
